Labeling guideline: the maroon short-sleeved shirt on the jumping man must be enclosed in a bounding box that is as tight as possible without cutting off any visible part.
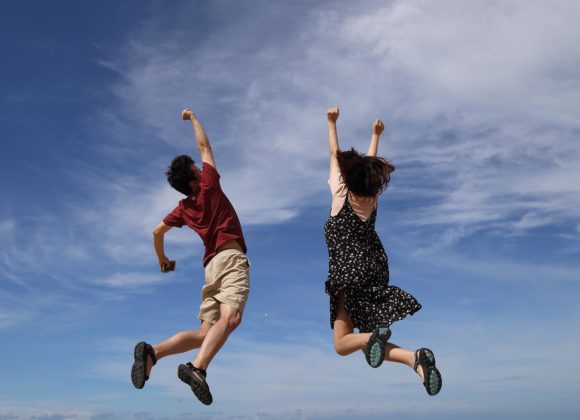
[163,162,247,267]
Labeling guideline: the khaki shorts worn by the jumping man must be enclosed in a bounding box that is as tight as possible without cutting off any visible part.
[197,249,250,324]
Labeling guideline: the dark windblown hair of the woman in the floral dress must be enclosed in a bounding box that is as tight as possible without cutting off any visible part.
[337,148,395,197]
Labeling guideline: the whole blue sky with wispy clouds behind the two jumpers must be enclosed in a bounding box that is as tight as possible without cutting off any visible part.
[0,0,580,419]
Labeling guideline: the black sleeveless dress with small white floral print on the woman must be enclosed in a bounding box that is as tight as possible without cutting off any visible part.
[324,194,421,332]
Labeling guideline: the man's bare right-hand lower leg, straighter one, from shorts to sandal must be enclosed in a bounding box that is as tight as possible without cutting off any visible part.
[192,303,242,370]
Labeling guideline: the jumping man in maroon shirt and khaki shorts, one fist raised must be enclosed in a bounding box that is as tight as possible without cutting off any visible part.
[131,109,250,405]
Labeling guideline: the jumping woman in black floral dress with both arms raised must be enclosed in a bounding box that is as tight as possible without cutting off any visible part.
[324,108,442,395]
